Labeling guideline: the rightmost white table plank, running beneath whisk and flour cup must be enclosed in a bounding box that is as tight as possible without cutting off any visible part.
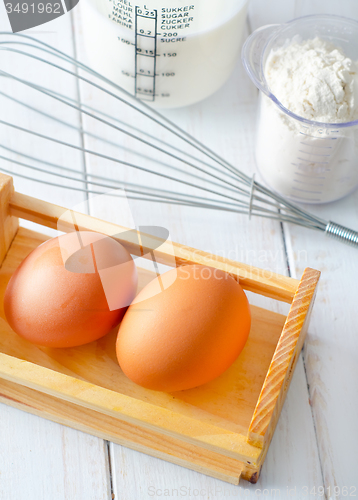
[250,0,358,498]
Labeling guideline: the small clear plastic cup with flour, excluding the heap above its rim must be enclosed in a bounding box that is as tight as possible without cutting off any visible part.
[242,15,358,203]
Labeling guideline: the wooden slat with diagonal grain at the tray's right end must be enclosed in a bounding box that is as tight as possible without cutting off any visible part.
[248,268,321,449]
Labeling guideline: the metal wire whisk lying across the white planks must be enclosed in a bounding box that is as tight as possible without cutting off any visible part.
[0,32,358,246]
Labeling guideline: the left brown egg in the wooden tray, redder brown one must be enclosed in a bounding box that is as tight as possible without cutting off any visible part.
[4,231,137,347]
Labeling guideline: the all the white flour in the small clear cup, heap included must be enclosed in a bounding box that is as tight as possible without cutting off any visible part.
[256,38,358,203]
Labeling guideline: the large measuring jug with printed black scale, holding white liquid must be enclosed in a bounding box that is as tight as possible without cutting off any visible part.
[80,0,248,108]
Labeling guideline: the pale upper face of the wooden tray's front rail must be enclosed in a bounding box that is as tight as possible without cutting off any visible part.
[0,353,261,464]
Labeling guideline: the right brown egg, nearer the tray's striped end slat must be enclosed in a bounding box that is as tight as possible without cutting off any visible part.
[116,266,251,392]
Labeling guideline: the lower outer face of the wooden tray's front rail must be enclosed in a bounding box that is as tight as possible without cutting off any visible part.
[0,379,248,484]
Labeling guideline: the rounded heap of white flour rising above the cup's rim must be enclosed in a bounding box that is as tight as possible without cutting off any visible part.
[265,38,358,123]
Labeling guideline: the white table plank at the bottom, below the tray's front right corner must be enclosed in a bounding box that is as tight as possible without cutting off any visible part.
[111,354,322,500]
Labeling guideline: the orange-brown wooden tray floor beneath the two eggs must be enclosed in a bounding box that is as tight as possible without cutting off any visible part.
[0,227,285,442]
